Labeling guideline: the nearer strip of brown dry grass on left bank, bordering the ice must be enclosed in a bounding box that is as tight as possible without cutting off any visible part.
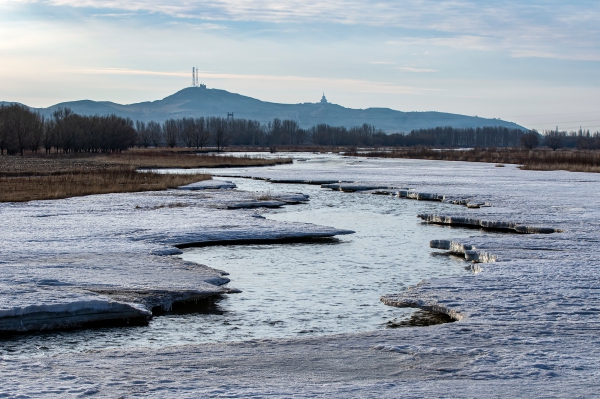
[0,166,211,202]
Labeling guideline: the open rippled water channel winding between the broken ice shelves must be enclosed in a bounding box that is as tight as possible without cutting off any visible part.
[0,159,488,357]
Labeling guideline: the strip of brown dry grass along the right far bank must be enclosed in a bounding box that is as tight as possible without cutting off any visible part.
[346,147,600,172]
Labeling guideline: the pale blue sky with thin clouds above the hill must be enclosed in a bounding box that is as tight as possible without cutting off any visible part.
[0,0,600,131]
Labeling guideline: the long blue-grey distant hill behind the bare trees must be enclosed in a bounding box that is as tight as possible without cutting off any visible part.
[15,87,526,133]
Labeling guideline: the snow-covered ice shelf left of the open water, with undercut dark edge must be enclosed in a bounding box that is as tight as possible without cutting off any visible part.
[0,184,350,333]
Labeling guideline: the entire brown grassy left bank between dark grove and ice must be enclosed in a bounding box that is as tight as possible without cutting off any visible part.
[0,149,292,202]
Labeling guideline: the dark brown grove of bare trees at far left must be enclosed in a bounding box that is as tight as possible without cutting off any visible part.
[0,104,137,155]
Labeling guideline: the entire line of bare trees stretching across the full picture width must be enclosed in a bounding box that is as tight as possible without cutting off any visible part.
[0,104,600,154]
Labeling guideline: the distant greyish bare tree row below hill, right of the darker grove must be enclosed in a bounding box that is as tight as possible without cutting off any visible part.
[136,121,537,149]
